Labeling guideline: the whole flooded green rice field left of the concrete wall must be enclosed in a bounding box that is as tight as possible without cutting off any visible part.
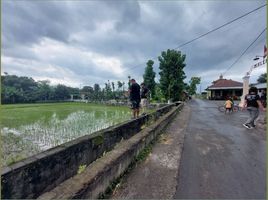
[0,102,131,166]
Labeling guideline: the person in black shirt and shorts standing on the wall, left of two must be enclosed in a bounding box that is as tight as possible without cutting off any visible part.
[129,79,141,119]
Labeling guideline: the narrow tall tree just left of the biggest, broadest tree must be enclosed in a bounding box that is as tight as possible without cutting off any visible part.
[143,60,155,97]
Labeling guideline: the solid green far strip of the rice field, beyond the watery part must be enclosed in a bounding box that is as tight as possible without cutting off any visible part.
[0,102,129,128]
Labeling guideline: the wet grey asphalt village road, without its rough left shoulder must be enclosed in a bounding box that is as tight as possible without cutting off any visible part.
[173,99,266,199]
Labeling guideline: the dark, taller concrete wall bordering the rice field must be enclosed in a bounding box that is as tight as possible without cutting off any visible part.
[1,104,179,199]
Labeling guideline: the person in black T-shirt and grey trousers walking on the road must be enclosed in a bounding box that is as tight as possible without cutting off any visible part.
[243,87,266,129]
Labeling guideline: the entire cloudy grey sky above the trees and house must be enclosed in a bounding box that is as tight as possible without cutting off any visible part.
[1,0,267,90]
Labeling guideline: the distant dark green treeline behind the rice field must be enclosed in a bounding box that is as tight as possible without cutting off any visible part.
[1,73,127,104]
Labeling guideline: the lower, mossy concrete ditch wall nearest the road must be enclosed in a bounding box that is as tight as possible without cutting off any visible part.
[38,104,183,200]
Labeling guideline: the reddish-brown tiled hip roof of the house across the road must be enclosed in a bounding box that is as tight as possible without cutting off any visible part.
[208,76,243,90]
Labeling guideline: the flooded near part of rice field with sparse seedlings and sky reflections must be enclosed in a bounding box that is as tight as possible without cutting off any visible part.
[1,109,130,165]
